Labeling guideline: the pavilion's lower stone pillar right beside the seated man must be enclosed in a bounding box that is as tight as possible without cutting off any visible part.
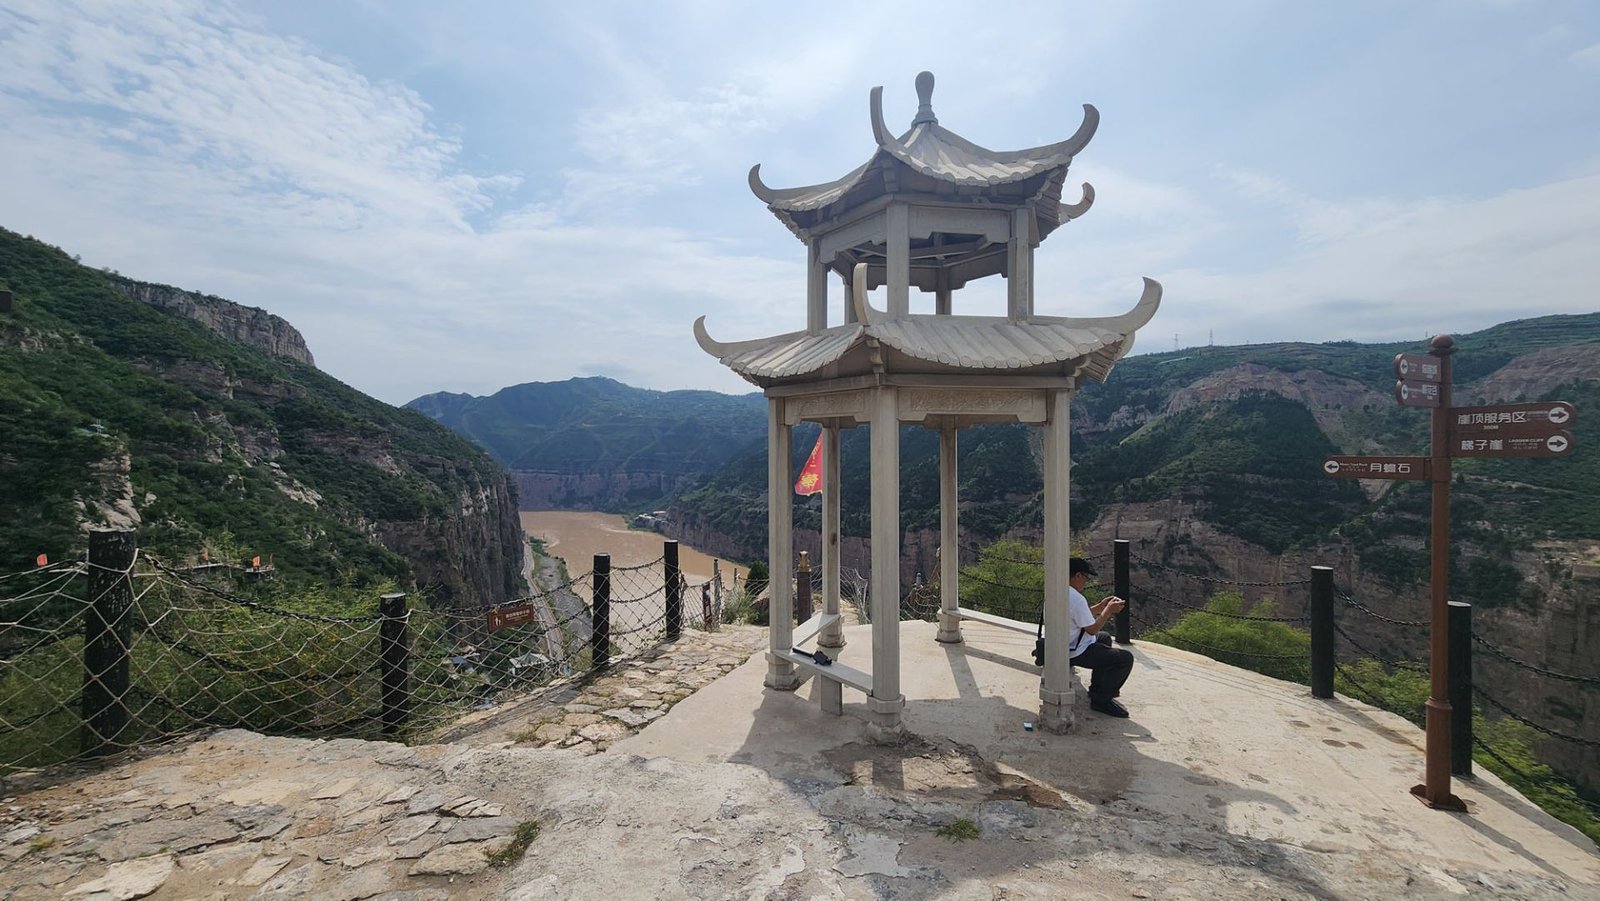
[1038,389,1074,733]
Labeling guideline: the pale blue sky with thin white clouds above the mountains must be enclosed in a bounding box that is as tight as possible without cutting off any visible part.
[0,0,1600,403]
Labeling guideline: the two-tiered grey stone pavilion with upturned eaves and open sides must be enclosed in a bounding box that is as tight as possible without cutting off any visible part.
[694,72,1162,739]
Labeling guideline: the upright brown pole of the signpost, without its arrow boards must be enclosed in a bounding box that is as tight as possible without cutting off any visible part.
[1411,334,1472,810]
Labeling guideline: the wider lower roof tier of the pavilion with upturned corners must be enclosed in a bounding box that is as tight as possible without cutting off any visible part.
[694,278,1162,387]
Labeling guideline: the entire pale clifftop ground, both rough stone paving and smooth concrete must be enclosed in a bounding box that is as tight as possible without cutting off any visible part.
[0,623,1600,901]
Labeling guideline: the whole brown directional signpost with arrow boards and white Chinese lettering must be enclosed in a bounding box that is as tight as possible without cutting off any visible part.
[1322,334,1578,810]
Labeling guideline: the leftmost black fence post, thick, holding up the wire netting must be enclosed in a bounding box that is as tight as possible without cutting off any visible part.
[78,528,134,757]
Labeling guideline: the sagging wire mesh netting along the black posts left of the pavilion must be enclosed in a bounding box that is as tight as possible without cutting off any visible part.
[0,540,715,776]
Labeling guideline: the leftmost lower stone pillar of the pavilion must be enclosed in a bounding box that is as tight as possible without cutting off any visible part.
[766,397,800,691]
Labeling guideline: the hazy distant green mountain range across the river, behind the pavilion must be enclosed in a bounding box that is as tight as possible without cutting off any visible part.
[408,314,1600,583]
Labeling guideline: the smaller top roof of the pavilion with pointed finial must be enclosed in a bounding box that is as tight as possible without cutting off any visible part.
[749,72,1099,238]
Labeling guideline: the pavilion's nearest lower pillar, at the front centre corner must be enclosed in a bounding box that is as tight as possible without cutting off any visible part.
[867,387,906,741]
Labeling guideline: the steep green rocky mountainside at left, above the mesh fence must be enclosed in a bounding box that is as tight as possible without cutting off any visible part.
[0,229,522,605]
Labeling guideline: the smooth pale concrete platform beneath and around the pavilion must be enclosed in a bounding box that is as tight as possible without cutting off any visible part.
[611,623,1600,898]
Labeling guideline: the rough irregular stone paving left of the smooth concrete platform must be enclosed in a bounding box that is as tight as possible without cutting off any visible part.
[0,627,765,901]
